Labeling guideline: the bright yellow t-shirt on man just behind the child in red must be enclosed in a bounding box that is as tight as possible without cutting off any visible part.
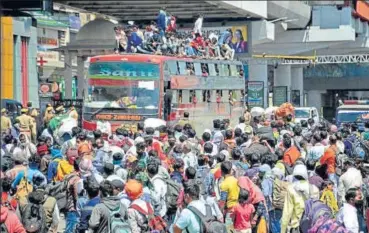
[220,176,240,208]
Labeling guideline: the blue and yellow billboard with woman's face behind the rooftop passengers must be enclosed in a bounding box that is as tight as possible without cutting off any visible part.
[177,23,251,55]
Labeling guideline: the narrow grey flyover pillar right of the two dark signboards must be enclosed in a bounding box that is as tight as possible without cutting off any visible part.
[291,67,304,107]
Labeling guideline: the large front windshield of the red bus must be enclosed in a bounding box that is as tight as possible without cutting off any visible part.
[86,62,160,109]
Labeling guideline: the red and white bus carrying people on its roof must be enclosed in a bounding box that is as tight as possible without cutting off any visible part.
[83,54,245,131]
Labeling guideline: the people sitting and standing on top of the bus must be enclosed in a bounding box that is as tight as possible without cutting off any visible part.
[114,8,239,60]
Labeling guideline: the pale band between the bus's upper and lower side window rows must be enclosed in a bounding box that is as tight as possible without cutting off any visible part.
[170,76,245,90]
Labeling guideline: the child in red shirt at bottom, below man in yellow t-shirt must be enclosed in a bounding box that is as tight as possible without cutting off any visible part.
[233,188,255,233]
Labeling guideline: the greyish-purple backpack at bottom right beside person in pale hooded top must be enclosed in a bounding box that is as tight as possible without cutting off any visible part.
[300,199,333,233]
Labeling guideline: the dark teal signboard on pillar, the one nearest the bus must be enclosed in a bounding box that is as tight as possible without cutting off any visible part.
[247,81,264,108]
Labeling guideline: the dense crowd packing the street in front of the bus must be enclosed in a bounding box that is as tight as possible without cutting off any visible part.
[0,101,369,233]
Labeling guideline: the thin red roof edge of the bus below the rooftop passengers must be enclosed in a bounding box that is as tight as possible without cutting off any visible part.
[90,53,242,65]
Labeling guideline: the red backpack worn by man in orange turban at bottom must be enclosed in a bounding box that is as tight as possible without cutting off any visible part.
[130,202,167,233]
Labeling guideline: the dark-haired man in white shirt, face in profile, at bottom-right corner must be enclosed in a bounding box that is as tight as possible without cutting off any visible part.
[337,188,363,233]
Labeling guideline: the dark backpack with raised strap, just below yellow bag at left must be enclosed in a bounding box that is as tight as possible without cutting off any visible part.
[46,174,76,212]
